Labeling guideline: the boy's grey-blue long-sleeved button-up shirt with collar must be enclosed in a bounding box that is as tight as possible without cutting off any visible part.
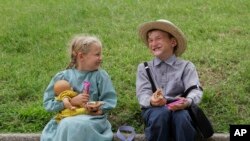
[136,55,203,107]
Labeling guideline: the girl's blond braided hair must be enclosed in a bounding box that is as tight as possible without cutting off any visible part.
[67,35,102,69]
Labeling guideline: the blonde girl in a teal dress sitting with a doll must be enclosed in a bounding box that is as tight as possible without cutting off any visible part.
[40,35,117,141]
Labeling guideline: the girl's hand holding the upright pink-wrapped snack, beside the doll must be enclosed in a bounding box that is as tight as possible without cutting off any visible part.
[70,93,89,107]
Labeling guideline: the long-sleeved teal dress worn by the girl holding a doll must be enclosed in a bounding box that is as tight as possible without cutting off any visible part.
[40,69,117,141]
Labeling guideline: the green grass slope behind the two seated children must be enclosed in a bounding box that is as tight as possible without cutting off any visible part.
[0,0,250,133]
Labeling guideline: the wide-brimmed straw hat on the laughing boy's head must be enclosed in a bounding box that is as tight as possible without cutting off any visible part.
[139,20,187,56]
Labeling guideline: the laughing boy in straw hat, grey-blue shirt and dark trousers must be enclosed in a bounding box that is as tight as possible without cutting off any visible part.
[136,20,202,141]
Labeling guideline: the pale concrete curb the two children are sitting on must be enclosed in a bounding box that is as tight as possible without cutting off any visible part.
[0,133,229,141]
